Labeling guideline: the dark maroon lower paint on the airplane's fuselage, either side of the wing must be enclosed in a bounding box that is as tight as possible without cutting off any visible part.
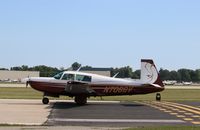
[29,81,164,96]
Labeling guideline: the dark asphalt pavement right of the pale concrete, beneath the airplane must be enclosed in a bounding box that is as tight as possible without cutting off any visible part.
[46,101,200,127]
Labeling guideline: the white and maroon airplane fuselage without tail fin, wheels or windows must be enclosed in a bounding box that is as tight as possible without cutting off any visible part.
[29,72,164,96]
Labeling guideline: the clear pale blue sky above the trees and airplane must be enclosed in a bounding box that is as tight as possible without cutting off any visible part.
[0,0,200,70]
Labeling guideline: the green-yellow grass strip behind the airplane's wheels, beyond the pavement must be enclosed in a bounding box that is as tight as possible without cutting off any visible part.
[0,87,200,101]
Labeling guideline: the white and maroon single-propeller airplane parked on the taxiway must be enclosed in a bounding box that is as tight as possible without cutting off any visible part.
[26,59,164,105]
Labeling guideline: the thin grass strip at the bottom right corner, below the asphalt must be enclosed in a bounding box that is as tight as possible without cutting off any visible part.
[126,126,200,130]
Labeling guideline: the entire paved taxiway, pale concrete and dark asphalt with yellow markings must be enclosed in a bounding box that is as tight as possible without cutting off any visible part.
[0,99,200,127]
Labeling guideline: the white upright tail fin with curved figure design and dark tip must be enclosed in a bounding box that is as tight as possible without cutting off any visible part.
[140,59,164,87]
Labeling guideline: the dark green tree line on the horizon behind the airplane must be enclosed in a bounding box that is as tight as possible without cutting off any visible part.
[0,62,200,82]
